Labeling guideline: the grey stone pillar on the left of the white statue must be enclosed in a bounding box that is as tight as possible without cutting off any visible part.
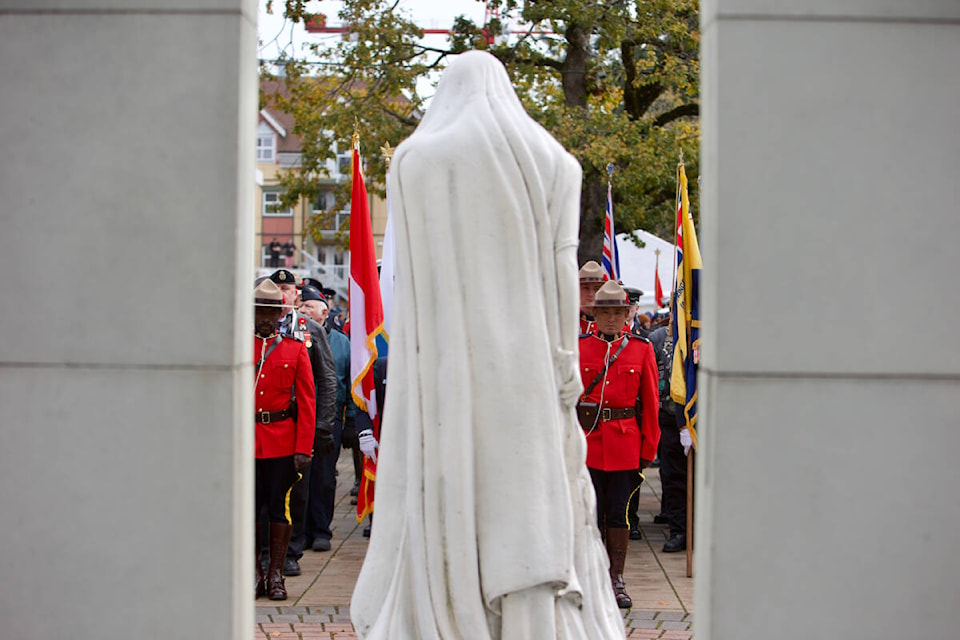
[0,0,257,640]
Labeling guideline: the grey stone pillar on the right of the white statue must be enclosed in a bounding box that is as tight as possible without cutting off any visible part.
[696,0,960,640]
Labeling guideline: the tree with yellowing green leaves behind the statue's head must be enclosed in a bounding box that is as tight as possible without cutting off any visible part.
[260,0,700,262]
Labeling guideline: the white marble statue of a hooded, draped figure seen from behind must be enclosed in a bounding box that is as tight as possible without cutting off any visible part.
[351,51,624,640]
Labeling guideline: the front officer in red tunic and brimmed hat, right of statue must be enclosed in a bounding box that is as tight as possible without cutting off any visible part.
[577,281,660,609]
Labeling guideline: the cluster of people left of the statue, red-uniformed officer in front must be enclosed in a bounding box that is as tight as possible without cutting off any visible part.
[254,269,361,600]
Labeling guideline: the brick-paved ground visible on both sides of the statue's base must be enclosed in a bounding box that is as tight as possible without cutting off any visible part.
[255,451,693,640]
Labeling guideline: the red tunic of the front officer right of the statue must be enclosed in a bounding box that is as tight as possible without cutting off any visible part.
[580,331,660,471]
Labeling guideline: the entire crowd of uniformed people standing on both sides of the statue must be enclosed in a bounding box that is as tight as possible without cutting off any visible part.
[254,261,690,608]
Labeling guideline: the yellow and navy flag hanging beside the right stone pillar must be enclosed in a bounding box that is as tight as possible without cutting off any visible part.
[670,163,702,448]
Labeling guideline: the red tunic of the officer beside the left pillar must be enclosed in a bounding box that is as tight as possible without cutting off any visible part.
[253,335,317,458]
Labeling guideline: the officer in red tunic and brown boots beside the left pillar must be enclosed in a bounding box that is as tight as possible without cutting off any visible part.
[253,280,316,600]
